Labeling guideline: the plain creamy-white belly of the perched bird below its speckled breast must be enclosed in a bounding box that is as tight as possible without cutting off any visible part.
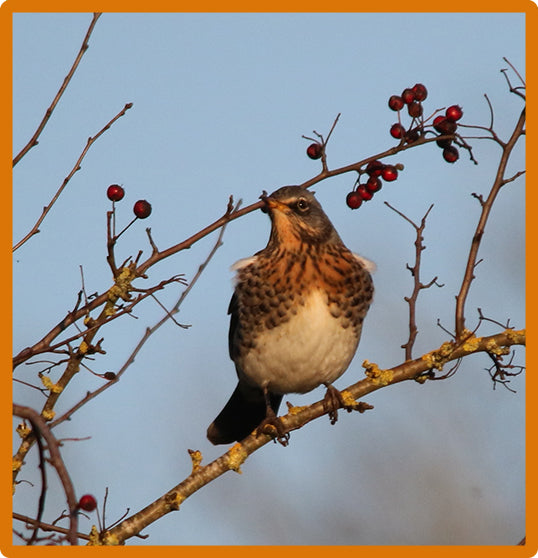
[238,291,359,394]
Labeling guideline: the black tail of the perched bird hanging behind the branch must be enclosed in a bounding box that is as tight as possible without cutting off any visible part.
[207,382,282,445]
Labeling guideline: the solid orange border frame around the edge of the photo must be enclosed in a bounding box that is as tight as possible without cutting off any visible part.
[0,0,538,558]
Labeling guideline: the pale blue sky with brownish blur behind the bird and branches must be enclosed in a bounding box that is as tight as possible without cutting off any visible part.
[13,13,525,545]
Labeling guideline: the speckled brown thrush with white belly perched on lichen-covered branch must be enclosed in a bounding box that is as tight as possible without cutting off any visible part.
[207,186,374,444]
